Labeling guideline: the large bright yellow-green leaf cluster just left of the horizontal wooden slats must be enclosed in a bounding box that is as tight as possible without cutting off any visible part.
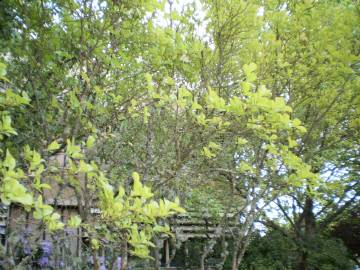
[98,172,185,258]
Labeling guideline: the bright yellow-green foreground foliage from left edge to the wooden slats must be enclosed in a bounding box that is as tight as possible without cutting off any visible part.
[0,64,185,258]
